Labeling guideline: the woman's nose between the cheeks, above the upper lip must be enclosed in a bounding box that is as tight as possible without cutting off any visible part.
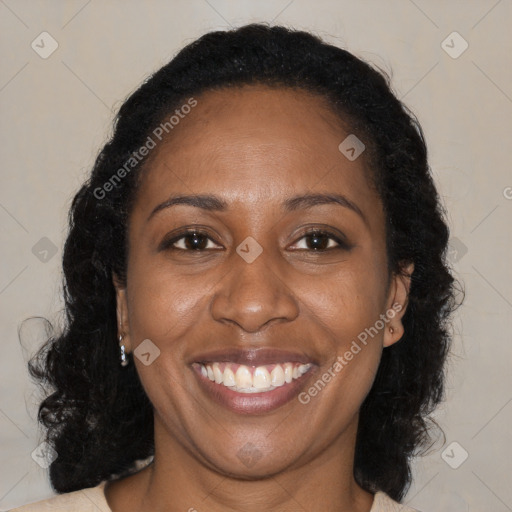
[211,250,299,333]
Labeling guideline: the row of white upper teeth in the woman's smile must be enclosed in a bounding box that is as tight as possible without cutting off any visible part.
[199,362,312,393]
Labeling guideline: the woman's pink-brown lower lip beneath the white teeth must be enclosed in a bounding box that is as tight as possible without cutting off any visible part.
[192,365,314,414]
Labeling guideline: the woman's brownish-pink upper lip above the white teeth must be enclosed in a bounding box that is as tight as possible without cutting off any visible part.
[191,348,316,366]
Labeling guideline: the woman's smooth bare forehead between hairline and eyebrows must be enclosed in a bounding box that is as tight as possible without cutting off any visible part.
[132,85,375,218]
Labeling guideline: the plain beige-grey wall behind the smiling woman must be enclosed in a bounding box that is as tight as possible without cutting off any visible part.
[0,0,512,512]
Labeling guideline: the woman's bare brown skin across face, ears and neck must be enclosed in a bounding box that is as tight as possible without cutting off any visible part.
[105,86,412,512]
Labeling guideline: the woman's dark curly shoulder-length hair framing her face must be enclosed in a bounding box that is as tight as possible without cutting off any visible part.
[29,24,457,501]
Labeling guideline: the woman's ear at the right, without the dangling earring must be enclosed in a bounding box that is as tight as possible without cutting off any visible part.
[383,263,414,347]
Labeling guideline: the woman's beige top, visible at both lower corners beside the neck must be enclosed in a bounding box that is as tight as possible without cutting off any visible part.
[10,480,417,512]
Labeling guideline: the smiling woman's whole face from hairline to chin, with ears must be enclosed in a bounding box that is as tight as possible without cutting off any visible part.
[116,86,408,477]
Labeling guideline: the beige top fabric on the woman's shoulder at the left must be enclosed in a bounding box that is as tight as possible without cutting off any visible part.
[10,481,112,512]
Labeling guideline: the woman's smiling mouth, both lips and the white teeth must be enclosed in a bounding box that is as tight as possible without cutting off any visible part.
[190,349,317,414]
